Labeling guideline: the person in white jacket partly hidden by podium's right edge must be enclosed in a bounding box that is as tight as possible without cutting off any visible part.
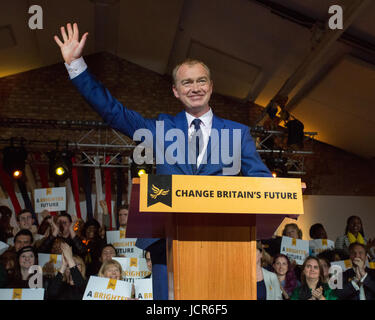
[256,242,282,300]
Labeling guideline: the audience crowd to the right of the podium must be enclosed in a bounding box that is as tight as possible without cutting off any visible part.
[256,216,375,300]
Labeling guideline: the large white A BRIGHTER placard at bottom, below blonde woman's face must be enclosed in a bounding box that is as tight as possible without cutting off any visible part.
[82,276,132,300]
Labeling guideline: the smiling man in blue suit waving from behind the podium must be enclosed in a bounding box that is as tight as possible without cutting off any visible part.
[55,24,272,299]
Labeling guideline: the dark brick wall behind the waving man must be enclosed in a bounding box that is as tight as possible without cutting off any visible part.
[0,53,375,195]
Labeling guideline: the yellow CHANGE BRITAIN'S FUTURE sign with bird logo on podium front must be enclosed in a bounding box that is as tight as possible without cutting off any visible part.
[139,174,303,215]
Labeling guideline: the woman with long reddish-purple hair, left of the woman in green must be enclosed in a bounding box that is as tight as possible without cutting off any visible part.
[272,254,299,300]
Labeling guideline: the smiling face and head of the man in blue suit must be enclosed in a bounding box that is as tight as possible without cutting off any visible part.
[173,63,212,118]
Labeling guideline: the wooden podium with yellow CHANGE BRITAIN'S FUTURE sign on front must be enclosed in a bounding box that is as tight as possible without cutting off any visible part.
[126,175,303,300]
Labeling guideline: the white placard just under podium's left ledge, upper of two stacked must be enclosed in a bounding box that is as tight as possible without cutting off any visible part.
[107,230,144,258]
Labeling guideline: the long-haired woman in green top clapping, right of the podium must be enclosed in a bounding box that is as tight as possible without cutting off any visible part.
[290,256,337,300]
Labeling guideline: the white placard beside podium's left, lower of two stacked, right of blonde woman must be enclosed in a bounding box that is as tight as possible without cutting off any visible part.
[113,257,151,283]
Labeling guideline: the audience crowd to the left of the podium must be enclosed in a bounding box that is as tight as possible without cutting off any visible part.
[0,201,152,300]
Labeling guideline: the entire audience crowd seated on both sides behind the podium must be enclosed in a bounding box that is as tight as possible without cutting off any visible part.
[0,202,375,300]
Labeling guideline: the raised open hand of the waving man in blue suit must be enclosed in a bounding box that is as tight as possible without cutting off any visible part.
[54,23,89,65]
